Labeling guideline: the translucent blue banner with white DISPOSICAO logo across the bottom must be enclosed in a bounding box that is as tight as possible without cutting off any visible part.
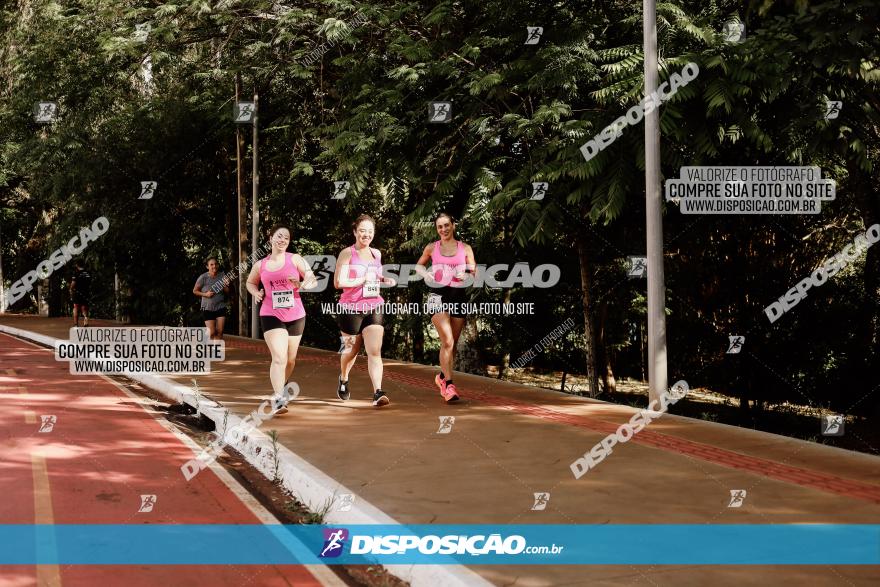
[0,524,880,565]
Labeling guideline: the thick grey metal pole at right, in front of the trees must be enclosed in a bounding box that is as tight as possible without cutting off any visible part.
[642,0,667,402]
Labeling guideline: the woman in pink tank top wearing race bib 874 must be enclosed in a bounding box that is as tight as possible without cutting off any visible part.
[247,225,317,414]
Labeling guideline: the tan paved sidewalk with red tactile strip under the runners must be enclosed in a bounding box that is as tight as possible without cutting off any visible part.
[0,315,880,586]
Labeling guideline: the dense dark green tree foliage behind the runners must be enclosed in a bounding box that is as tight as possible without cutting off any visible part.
[0,0,880,420]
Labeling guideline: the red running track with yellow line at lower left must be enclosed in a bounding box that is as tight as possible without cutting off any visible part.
[0,334,336,587]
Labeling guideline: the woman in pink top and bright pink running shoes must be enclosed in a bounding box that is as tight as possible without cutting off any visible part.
[416,212,477,403]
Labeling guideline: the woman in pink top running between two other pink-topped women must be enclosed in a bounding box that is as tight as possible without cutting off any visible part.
[333,214,396,407]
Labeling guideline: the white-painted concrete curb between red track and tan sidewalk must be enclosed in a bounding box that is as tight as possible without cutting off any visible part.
[0,324,492,587]
